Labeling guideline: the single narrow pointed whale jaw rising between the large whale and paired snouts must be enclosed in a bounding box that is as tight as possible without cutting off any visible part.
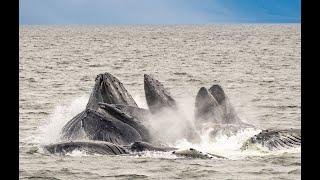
[144,74,177,113]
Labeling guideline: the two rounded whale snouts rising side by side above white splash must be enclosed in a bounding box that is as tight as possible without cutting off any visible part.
[194,85,254,136]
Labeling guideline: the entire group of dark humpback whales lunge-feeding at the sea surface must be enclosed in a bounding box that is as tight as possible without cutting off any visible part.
[44,73,301,158]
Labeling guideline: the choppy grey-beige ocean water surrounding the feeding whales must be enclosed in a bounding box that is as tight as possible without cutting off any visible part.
[19,24,301,179]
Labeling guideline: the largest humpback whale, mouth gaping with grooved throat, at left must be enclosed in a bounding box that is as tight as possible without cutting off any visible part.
[62,73,151,145]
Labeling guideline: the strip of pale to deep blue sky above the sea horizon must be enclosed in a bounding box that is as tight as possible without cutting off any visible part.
[19,0,301,24]
